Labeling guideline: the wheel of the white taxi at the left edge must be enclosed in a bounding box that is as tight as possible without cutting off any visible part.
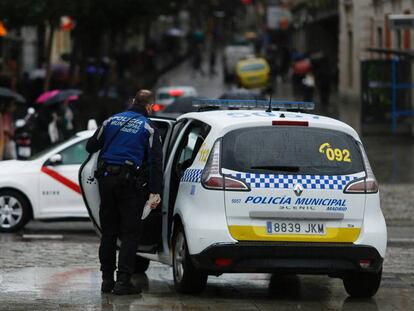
[0,190,31,232]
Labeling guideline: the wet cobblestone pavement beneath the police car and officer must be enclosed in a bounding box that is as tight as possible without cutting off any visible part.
[0,228,414,311]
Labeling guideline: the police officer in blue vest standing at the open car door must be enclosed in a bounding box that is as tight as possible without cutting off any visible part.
[86,90,162,295]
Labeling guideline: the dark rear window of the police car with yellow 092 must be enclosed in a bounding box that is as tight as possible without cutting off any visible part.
[222,126,364,175]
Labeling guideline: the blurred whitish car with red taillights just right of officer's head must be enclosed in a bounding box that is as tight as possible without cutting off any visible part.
[154,86,197,112]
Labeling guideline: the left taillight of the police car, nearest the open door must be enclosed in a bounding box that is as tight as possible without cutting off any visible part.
[201,140,250,191]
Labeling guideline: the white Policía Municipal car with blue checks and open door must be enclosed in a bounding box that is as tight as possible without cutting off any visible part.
[80,100,387,297]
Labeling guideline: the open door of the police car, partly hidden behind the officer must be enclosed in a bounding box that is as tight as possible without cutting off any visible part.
[79,118,175,253]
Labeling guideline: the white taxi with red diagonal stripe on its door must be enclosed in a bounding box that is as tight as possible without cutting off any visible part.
[0,131,93,232]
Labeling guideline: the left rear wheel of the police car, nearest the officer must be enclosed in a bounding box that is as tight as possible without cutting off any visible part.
[173,227,208,294]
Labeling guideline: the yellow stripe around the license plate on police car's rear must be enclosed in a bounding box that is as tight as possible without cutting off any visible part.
[229,226,361,243]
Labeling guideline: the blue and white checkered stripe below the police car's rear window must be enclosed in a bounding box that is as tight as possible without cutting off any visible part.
[231,172,364,190]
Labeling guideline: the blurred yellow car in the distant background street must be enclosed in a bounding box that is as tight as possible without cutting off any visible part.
[236,57,271,89]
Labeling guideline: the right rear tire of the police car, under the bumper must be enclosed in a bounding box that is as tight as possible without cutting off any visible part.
[343,268,382,298]
